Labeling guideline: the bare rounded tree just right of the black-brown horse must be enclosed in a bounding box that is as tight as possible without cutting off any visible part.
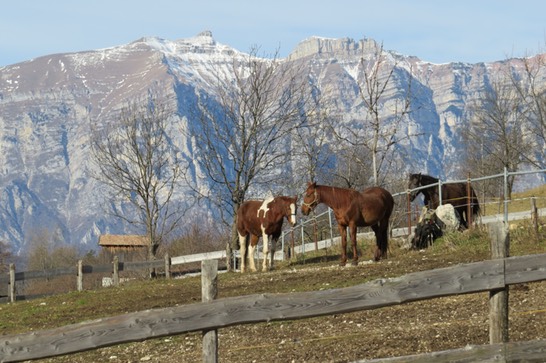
[463,75,530,198]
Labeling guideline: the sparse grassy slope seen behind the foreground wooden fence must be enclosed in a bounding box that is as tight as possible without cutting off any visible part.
[0,228,546,363]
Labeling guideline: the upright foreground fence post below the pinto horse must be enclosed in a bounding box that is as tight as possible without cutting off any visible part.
[201,260,218,363]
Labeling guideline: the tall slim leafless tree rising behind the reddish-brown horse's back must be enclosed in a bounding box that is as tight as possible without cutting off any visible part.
[328,44,413,185]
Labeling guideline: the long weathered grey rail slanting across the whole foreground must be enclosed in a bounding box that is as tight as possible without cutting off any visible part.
[0,254,546,362]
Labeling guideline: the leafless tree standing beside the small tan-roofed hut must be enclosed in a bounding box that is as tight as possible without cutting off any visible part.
[91,97,182,259]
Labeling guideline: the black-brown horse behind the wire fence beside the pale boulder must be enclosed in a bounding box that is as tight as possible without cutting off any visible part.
[408,173,480,228]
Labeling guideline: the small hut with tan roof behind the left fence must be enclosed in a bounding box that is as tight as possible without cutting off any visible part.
[99,234,150,262]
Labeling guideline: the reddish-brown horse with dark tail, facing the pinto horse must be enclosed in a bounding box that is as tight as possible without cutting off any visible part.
[301,183,394,266]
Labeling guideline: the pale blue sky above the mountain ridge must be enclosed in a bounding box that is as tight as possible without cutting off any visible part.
[0,0,546,67]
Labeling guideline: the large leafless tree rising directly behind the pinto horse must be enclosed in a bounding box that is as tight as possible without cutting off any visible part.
[187,47,307,268]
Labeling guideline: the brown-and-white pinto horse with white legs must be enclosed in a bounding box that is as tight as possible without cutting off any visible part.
[237,196,297,272]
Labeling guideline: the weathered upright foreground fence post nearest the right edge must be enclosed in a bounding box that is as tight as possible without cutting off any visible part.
[489,222,510,344]
